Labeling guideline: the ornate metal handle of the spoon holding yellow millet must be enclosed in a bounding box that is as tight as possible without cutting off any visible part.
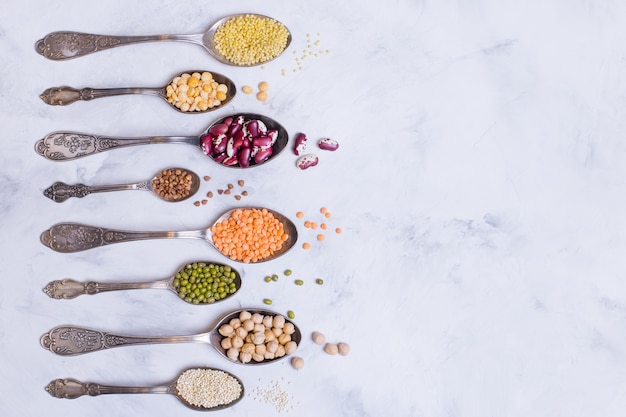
[35,32,199,61]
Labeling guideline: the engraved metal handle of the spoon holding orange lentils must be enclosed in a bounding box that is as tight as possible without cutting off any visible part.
[40,223,210,253]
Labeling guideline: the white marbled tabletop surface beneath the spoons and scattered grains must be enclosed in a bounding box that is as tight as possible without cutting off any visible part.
[0,0,626,417]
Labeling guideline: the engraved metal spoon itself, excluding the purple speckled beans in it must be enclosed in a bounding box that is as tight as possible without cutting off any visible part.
[35,113,289,168]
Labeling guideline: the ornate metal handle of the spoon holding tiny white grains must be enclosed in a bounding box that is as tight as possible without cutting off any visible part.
[46,378,174,399]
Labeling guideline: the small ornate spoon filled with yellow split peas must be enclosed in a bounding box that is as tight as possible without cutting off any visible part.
[39,71,237,114]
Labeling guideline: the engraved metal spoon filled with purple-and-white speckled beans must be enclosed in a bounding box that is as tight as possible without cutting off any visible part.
[35,113,289,168]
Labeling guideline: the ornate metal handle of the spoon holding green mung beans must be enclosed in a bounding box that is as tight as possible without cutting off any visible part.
[43,278,171,300]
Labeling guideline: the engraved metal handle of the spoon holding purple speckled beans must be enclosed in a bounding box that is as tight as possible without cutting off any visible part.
[35,132,200,161]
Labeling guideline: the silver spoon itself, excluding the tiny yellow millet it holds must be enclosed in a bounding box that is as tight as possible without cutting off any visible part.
[35,13,291,66]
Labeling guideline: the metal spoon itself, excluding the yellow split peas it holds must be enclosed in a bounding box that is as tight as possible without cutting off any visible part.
[39,70,237,114]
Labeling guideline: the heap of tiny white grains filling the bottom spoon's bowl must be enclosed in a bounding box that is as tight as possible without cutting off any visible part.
[176,369,242,408]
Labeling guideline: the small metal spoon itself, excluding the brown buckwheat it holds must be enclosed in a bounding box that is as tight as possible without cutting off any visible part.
[43,168,200,203]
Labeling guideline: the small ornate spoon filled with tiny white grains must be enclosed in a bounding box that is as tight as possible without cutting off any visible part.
[45,367,244,411]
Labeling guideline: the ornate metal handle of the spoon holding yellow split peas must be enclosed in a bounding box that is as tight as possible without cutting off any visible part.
[39,86,165,106]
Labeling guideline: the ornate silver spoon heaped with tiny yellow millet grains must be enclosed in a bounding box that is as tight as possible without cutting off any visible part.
[35,13,291,67]
